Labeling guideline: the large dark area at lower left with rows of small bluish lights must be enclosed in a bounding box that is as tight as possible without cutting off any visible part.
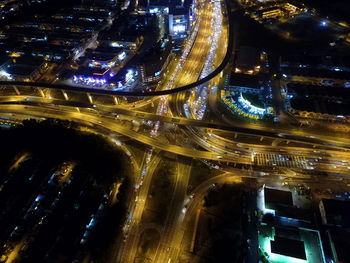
[0,120,130,262]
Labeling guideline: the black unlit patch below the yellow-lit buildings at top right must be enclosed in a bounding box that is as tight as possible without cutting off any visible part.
[232,3,350,56]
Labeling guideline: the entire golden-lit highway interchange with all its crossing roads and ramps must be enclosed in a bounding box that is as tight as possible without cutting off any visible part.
[0,0,350,263]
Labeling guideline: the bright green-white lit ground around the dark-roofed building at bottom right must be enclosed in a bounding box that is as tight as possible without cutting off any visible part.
[259,225,325,263]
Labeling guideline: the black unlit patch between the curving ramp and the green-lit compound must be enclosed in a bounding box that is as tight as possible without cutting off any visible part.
[195,184,246,263]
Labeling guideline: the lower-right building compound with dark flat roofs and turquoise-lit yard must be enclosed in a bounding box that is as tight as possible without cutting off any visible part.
[258,187,325,263]
